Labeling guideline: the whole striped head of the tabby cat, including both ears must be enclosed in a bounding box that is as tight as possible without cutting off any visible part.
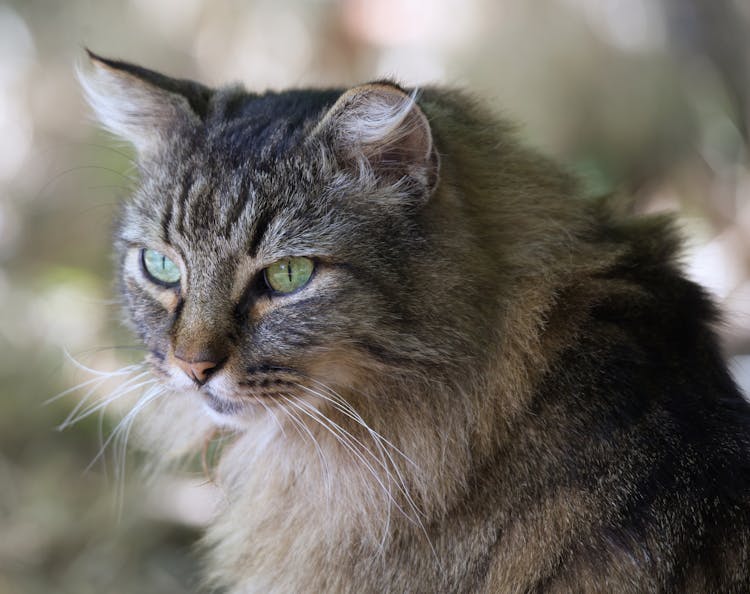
[82,54,446,426]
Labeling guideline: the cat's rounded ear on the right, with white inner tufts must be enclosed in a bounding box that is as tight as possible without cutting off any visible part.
[316,82,439,193]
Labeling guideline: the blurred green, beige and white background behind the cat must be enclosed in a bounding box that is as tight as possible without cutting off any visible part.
[0,0,750,594]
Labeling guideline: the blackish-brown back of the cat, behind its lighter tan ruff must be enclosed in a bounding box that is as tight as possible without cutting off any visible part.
[482,202,750,592]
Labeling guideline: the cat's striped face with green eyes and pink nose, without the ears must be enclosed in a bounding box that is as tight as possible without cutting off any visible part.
[118,149,418,424]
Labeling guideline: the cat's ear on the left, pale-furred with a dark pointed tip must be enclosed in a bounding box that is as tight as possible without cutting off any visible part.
[78,50,212,159]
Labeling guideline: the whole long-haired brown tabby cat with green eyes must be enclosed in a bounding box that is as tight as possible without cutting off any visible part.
[82,55,750,593]
